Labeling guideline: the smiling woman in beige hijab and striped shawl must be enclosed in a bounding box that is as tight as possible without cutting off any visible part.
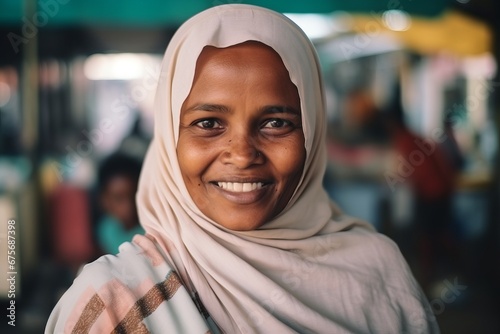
[46,5,438,333]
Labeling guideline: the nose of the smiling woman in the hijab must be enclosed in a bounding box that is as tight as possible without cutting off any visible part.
[221,135,264,169]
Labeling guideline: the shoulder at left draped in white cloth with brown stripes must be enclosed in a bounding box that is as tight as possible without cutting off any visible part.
[46,236,211,333]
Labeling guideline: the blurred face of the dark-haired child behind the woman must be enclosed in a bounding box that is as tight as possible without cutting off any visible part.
[100,175,139,230]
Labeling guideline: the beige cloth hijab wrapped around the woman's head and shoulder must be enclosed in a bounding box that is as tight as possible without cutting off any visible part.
[137,5,438,333]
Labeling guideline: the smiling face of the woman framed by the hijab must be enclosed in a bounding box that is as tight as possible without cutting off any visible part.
[177,42,306,231]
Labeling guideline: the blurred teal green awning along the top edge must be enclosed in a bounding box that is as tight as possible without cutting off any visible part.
[0,0,454,27]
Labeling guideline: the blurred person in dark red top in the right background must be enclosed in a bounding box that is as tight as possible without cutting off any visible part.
[386,102,461,291]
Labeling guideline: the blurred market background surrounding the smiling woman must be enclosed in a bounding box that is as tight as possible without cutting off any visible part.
[0,0,500,333]
